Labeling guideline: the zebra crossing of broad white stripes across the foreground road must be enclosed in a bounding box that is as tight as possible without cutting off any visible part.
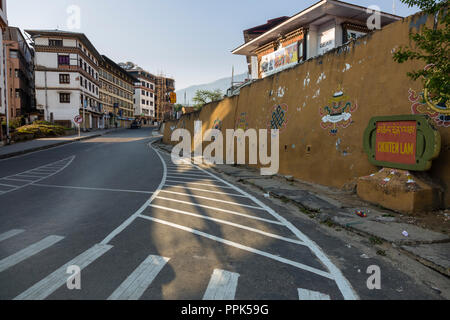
[0,229,330,300]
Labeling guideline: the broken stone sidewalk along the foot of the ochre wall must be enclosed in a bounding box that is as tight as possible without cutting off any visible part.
[156,142,450,276]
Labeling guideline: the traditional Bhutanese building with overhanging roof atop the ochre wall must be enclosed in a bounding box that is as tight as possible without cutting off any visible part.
[232,0,402,79]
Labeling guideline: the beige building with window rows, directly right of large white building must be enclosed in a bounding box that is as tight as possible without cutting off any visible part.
[99,56,138,128]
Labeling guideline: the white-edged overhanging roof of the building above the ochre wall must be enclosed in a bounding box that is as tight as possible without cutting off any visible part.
[232,0,403,55]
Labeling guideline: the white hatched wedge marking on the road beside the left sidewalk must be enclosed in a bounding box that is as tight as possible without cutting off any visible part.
[0,156,75,196]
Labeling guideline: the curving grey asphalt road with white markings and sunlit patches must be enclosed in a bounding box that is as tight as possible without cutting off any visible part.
[0,129,440,300]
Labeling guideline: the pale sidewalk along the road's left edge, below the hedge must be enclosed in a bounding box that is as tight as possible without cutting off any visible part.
[0,128,125,159]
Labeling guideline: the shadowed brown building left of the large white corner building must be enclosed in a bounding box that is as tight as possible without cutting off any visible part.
[3,27,38,123]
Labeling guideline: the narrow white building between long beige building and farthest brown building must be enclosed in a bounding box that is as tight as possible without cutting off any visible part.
[129,70,156,121]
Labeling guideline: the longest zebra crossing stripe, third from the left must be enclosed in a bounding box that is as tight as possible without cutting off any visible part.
[14,244,112,300]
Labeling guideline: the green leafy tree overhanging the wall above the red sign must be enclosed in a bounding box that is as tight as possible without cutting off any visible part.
[394,0,450,114]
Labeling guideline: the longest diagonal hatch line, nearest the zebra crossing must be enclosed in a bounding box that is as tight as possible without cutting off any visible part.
[139,215,334,280]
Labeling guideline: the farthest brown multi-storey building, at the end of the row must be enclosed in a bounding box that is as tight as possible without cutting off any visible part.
[155,75,175,122]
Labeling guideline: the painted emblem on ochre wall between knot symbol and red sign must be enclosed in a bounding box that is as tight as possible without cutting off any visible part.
[320,90,358,136]
